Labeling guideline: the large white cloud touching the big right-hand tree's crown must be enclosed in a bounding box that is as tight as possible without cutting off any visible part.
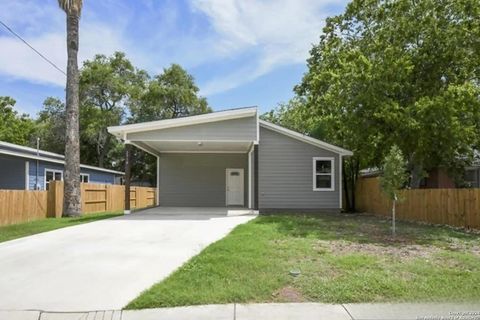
[192,0,344,95]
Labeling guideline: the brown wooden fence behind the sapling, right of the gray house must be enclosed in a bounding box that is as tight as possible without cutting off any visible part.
[355,177,480,229]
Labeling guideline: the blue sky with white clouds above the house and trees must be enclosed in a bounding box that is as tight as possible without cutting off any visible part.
[0,0,346,95]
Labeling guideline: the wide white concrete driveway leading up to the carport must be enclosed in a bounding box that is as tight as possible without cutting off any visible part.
[0,208,254,311]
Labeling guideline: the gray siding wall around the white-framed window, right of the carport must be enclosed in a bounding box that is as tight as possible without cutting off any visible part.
[258,127,340,211]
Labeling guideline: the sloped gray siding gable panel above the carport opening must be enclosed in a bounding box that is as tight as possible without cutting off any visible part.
[128,117,257,141]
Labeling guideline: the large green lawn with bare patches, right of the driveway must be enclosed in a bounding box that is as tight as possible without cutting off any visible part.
[126,214,480,309]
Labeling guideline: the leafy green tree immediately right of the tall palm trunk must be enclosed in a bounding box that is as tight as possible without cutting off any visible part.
[80,52,148,168]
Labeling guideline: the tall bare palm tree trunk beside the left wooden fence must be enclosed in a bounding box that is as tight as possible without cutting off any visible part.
[58,0,82,216]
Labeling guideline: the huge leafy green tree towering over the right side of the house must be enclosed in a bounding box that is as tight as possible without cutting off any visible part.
[295,0,480,207]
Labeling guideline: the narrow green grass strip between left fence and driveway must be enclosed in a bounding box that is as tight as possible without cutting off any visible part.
[0,212,121,242]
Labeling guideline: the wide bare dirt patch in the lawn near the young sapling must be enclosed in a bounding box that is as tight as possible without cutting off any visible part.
[316,241,439,259]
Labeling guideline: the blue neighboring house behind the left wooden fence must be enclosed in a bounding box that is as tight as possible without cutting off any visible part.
[0,141,124,190]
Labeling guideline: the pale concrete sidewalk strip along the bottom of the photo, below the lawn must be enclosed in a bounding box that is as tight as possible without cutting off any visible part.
[0,303,480,320]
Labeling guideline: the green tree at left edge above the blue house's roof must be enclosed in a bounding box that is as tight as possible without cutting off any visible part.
[0,96,35,146]
